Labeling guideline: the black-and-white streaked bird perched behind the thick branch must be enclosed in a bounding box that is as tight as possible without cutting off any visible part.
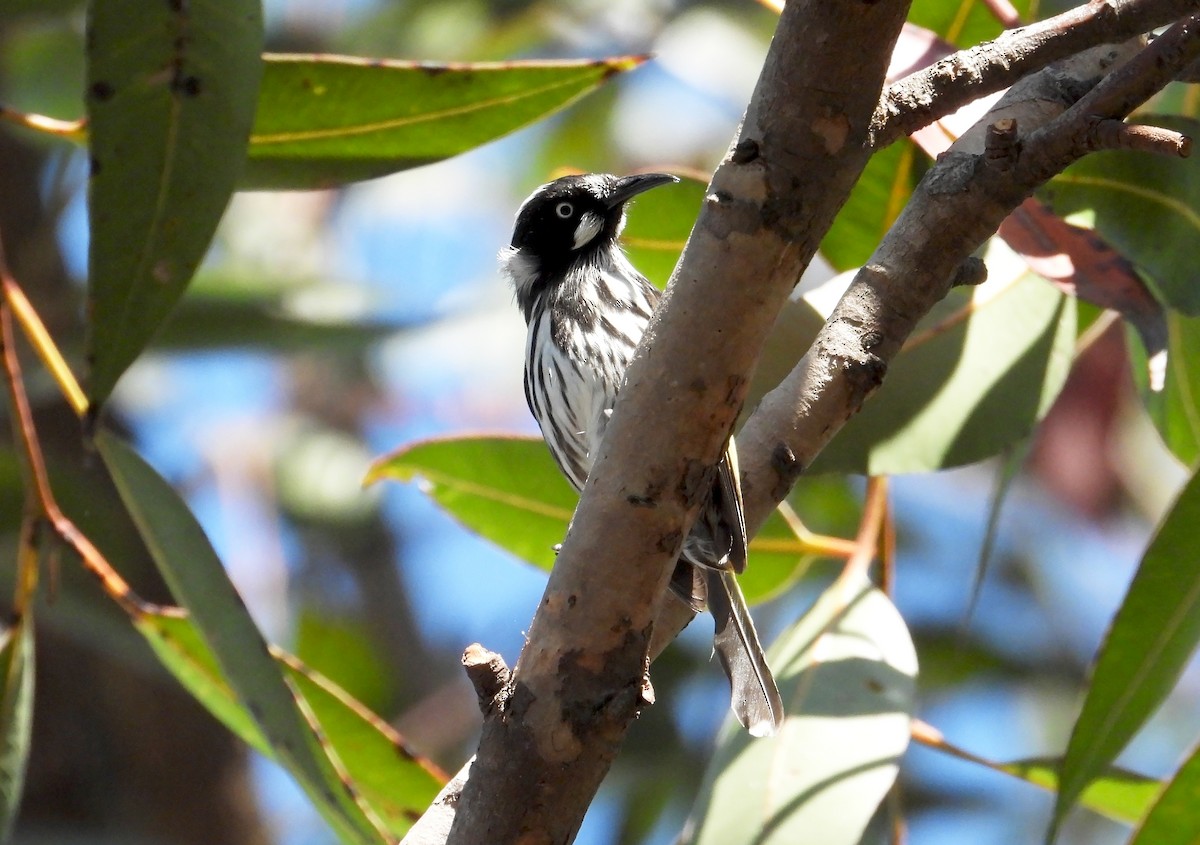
[499,173,784,736]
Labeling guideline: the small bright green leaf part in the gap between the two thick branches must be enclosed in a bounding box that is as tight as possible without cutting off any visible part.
[821,138,923,271]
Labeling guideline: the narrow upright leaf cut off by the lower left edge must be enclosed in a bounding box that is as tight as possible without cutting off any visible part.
[0,610,34,841]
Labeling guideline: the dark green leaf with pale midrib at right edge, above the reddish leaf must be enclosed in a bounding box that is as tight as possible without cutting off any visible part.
[1042,115,1200,316]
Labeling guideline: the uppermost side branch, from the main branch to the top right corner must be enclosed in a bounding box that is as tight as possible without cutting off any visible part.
[872,0,1196,148]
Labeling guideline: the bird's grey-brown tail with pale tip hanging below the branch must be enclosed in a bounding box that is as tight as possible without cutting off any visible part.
[701,569,784,737]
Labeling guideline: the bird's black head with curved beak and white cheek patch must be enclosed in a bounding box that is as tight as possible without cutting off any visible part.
[508,173,679,288]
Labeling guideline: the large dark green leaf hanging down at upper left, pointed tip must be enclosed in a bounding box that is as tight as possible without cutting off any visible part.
[86,0,263,404]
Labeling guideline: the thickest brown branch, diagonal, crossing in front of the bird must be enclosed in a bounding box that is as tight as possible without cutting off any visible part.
[439,0,907,844]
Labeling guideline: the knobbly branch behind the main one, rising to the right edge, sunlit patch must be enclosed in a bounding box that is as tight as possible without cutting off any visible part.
[738,16,1200,531]
